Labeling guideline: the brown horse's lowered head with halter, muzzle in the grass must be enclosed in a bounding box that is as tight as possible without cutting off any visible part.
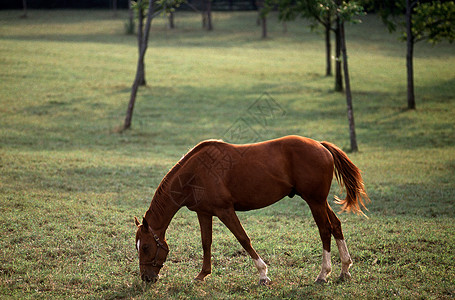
[134,218,169,283]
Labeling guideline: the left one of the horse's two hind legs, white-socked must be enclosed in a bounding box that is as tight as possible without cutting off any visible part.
[307,201,332,283]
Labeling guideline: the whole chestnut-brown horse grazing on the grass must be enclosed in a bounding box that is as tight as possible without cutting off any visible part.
[135,136,369,284]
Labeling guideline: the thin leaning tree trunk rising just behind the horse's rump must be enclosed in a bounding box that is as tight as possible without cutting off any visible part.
[340,22,359,152]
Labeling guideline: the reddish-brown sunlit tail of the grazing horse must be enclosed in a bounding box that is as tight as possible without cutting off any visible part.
[321,142,370,216]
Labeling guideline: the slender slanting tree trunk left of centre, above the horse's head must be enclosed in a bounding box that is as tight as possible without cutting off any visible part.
[123,1,153,130]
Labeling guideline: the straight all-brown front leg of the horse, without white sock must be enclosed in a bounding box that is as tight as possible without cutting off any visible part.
[195,213,213,281]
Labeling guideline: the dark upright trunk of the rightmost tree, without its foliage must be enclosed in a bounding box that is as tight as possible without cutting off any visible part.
[406,0,416,109]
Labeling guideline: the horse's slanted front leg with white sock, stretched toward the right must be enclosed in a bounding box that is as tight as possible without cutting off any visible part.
[217,208,270,285]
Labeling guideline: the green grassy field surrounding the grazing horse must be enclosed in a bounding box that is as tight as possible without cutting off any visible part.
[0,11,455,299]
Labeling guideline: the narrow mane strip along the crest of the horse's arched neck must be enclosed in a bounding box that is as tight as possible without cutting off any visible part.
[150,140,223,213]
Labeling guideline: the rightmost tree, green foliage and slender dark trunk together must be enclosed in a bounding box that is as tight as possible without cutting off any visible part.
[370,0,455,109]
